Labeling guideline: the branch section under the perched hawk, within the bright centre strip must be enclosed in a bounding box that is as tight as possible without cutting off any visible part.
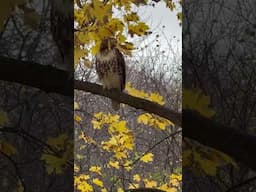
[74,80,181,126]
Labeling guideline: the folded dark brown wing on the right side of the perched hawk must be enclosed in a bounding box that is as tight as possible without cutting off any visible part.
[115,48,126,91]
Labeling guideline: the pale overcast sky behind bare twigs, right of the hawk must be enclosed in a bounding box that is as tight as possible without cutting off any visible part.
[118,1,182,77]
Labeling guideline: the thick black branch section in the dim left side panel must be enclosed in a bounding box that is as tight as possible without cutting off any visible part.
[0,57,73,97]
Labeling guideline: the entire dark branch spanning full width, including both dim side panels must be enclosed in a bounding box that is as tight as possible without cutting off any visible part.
[0,57,256,171]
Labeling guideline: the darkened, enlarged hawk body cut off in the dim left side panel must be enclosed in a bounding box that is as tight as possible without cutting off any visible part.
[50,0,74,77]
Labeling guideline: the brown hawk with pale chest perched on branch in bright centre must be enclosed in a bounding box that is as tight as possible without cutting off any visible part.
[96,37,126,111]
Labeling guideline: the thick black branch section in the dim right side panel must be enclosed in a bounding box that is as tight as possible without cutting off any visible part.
[182,110,256,171]
